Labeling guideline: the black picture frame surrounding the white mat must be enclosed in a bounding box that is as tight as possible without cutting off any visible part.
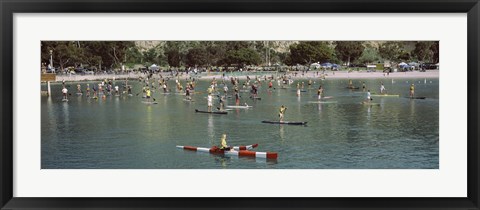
[0,0,480,209]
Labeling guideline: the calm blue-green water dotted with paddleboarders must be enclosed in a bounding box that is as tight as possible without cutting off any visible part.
[41,78,439,169]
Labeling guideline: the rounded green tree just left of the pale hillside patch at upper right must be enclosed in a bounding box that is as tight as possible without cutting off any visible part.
[335,41,365,65]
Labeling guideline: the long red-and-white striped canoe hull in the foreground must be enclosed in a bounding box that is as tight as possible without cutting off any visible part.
[176,145,278,159]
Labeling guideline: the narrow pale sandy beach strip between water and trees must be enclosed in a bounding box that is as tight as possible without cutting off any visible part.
[51,70,440,82]
